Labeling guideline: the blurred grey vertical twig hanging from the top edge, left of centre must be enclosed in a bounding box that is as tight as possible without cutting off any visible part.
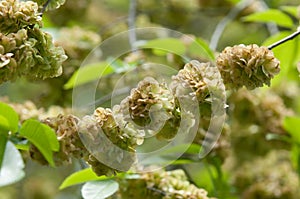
[128,0,137,51]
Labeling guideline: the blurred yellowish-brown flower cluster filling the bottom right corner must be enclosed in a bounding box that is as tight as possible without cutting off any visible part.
[233,150,300,199]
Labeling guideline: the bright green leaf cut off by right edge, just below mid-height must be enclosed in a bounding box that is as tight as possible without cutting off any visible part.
[283,117,300,144]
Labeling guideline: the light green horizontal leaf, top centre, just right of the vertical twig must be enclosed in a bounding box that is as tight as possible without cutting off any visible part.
[141,38,186,55]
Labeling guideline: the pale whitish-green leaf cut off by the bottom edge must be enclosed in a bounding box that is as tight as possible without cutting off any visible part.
[81,180,119,199]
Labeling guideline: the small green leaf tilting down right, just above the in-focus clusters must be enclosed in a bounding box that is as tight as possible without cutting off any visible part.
[187,38,215,61]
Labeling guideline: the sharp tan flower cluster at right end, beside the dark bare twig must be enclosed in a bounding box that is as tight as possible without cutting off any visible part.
[216,44,280,89]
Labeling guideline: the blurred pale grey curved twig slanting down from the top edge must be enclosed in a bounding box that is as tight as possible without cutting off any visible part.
[209,0,253,50]
